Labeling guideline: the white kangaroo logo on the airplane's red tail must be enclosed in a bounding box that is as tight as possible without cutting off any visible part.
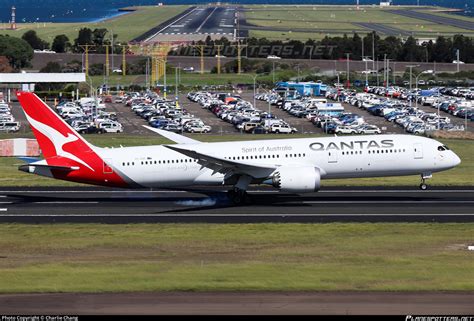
[25,113,95,172]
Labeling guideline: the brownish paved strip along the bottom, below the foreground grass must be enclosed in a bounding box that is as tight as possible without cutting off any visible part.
[0,292,474,314]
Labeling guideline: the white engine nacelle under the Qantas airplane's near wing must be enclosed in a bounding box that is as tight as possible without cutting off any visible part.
[272,166,321,193]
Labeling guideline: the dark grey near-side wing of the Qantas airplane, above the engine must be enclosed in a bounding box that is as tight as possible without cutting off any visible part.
[164,145,278,178]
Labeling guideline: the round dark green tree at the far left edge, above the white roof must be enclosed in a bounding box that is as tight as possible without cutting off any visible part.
[0,35,33,69]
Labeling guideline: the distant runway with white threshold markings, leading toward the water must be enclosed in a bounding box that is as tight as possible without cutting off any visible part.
[146,6,236,42]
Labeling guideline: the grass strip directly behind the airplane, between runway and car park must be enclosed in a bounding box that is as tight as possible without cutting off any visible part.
[0,134,474,188]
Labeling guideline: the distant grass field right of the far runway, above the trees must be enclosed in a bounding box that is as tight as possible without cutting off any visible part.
[245,5,474,40]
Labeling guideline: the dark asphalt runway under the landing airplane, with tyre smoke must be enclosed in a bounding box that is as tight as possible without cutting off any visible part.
[0,187,474,224]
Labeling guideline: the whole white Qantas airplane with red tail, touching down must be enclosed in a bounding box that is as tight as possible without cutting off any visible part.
[17,92,461,204]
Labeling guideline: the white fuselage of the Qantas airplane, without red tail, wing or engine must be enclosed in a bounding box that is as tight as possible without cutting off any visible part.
[97,135,460,187]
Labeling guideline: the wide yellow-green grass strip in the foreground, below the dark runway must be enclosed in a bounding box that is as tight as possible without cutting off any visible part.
[0,223,474,293]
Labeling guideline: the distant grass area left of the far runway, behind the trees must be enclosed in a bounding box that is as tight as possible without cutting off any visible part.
[0,5,189,43]
